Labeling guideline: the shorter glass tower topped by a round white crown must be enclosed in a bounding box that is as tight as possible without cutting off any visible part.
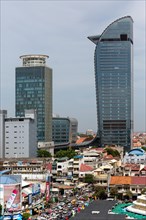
[15,55,52,142]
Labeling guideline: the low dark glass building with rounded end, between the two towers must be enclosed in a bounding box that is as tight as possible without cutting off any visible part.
[52,117,78,144]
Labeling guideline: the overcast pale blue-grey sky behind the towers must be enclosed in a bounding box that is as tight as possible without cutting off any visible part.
[0,0,146,132]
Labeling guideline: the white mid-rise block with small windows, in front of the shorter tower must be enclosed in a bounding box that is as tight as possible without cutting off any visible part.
[5,110,37,158]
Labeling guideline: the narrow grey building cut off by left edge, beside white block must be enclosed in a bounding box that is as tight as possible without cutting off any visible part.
[0,110,7,158]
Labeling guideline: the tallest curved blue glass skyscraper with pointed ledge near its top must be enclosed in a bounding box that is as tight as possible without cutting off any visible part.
[88,16,133,151]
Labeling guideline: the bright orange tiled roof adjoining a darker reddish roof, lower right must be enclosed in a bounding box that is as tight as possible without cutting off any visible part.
[110,176,131,185]
